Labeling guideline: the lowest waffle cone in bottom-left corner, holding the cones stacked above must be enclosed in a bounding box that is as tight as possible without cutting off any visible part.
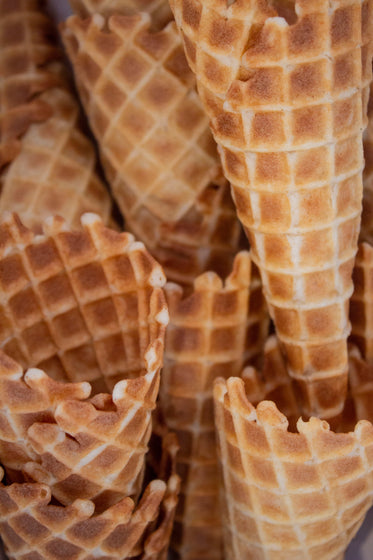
[0,434,179,560]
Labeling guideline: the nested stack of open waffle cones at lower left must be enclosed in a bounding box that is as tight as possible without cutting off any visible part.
[0,214,179,559]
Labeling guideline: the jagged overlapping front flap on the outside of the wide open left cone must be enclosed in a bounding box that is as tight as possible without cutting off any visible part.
[24,368,162,513]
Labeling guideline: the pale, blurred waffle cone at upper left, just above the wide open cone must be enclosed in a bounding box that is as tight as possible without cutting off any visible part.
[0,88,111,229]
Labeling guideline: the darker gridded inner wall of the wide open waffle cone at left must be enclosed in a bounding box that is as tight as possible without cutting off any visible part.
[0,214,168,393]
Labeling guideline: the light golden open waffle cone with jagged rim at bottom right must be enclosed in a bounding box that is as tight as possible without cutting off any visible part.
[214,378,373,560]
